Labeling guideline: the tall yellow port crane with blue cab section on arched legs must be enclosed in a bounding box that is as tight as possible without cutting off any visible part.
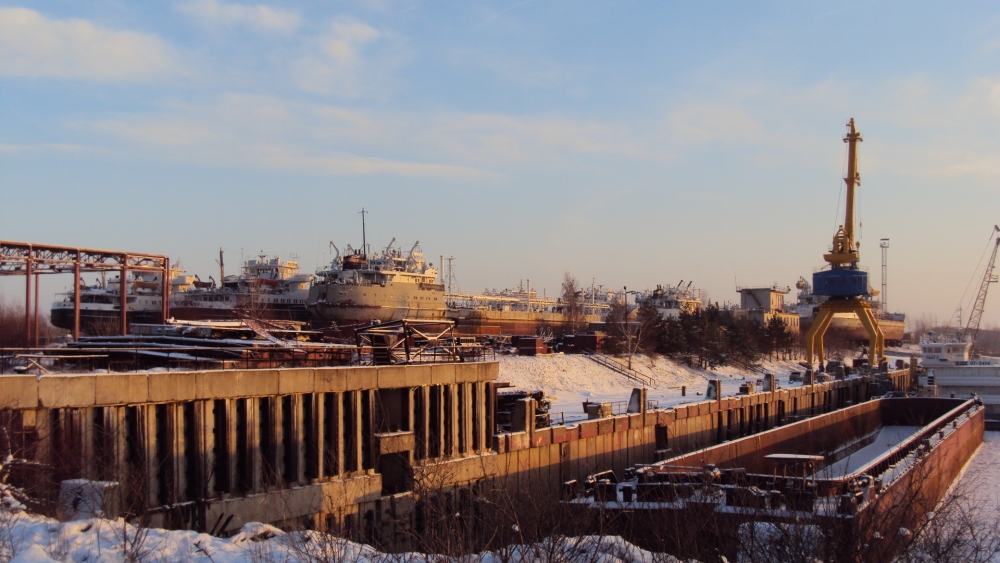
[806,118,885,369]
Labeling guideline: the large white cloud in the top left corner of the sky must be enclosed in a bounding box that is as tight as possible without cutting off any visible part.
[0,8,177,80]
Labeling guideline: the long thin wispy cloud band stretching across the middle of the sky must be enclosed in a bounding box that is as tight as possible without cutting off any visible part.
[86,94,645,181]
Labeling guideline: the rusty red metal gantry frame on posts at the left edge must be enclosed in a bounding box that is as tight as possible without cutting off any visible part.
[0,240,170,347]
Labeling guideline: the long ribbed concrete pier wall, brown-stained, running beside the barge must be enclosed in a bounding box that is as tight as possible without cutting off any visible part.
[0,362,870,540]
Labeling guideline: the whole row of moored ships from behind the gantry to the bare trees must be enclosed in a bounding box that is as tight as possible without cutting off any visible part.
[51,240,620,334]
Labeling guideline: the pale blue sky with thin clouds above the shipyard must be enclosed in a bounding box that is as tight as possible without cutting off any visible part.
[0,0,1000,324]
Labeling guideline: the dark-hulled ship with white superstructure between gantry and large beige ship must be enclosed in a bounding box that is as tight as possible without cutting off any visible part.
[170,254,313,322]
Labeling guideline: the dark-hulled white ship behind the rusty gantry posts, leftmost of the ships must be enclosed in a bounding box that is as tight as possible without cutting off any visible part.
[49,270,187,334]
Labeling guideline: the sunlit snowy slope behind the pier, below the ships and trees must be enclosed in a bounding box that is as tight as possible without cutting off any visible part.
[497,354,803,418]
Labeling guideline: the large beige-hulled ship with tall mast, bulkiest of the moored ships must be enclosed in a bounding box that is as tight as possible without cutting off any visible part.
[306,239,446,328]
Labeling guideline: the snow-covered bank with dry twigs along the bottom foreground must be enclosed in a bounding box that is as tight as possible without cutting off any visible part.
[0,508,680,563]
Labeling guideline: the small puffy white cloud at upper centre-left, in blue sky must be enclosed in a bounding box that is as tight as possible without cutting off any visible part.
[293,18,386,97]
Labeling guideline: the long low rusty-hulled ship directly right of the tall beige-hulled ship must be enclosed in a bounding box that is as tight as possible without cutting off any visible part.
[446,285,619,335]
